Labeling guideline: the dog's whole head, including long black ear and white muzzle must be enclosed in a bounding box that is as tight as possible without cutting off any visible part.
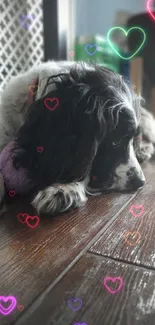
[14,63,144,190]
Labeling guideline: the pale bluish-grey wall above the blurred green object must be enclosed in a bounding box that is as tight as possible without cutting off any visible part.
[75,0,147,36]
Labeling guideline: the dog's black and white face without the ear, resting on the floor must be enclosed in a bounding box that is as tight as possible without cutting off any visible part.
[88,67,145,193]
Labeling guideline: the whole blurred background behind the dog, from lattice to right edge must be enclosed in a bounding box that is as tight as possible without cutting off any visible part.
[0,0,155,115]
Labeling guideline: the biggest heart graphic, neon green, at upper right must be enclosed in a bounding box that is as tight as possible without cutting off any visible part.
[107,27,146,60]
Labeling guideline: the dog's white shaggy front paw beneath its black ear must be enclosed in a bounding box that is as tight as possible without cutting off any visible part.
[32,182,87,215]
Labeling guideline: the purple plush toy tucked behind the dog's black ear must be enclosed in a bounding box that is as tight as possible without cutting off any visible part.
[0,140,36,194]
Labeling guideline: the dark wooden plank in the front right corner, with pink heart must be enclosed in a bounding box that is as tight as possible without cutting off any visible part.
[13,254,155,325]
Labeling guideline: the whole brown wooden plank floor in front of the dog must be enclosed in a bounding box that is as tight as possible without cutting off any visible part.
[0,162,155,325]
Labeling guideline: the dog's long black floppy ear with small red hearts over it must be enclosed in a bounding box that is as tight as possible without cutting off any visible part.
[13,74,106,186]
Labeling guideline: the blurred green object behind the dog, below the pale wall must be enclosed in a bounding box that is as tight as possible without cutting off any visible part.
[75,36,120,73]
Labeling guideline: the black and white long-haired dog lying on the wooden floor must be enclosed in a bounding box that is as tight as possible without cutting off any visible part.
[0,62,155,214]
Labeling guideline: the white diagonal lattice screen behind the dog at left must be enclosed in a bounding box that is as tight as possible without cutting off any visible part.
[0,0,43,91]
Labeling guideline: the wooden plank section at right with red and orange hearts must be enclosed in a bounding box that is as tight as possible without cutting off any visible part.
[90,161,155,268]
